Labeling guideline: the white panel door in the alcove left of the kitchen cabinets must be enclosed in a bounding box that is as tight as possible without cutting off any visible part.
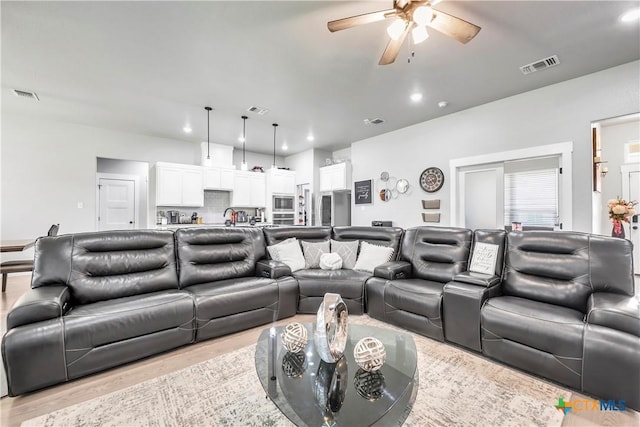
[98,178,135,231]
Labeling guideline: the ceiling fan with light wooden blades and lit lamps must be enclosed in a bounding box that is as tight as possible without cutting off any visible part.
[327,0,480,65]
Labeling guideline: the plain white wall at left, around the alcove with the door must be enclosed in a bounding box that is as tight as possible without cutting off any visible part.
[0,113,199,244]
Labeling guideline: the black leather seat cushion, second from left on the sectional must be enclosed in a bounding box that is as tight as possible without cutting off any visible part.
[185,277,278,320]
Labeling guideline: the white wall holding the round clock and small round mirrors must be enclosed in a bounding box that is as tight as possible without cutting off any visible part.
[351,61,640,231]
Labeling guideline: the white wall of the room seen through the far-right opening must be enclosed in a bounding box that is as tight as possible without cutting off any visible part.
[598,121,640,235]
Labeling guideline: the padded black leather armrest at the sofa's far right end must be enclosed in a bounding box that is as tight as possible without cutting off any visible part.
[587,292,640,337]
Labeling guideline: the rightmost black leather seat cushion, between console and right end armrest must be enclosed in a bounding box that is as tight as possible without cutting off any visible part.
[481,296,584,359]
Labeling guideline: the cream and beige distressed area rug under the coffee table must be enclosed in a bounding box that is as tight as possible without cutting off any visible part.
[22,316,571,427]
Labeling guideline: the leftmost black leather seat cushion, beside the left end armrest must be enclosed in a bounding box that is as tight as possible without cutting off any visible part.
[63,290,194,364]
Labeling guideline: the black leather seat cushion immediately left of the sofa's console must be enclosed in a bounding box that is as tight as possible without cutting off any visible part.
[384,279,444,319]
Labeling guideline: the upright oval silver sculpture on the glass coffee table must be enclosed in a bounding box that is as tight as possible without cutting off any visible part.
[313,293,348,363]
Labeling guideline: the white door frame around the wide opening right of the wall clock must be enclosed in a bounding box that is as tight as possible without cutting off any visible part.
[449,141,573,230]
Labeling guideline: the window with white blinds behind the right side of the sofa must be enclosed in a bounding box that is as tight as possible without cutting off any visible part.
[504,168,559,227]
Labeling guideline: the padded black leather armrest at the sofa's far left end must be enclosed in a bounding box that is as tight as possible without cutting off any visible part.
[7,286,71,329]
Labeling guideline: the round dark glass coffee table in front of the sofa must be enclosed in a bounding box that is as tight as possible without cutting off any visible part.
[255,323,418,427]
